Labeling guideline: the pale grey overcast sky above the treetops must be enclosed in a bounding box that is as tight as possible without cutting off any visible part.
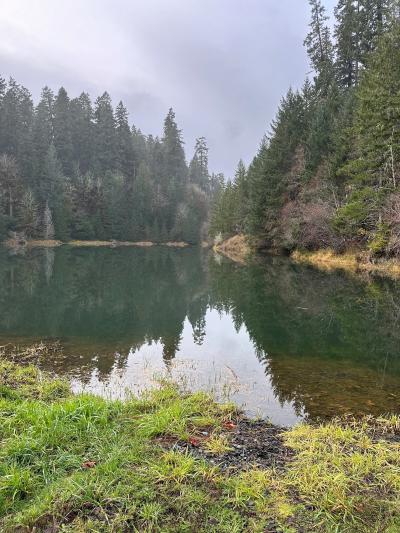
[0,0,334,176]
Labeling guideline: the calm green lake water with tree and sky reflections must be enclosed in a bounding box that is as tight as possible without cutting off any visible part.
[0,247,400,425]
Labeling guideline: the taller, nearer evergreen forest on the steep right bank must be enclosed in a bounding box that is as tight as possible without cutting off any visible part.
[210,0,400,258]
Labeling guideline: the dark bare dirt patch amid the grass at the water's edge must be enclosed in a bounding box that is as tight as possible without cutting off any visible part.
[157,418,294,470]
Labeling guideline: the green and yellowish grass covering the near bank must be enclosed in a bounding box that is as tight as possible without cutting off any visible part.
[0,359,400,533]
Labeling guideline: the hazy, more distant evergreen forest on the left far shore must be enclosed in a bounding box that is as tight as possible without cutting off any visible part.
[0,81,223,243]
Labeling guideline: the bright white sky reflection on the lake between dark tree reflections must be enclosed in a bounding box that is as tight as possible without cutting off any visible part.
[73,311,304,425]
